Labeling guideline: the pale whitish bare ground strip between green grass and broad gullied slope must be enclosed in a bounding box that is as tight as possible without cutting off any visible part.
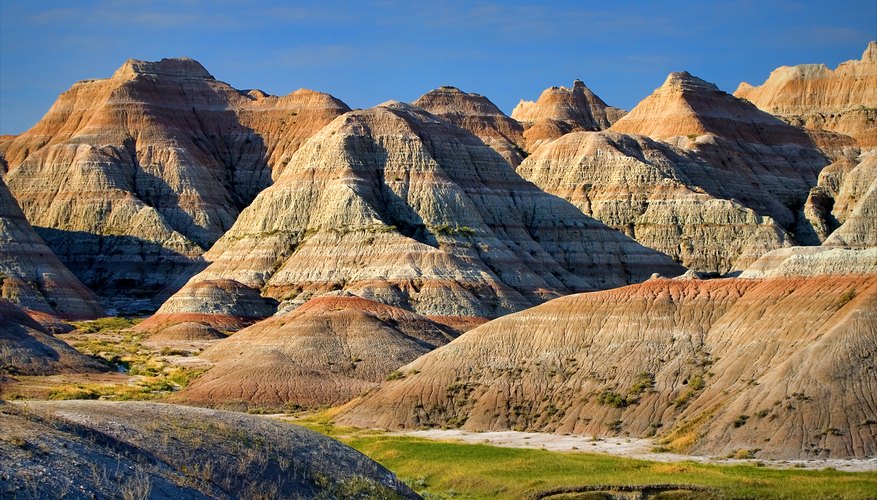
[393,429,877,472]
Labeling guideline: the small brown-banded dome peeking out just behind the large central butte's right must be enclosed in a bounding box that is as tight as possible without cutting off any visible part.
[412,87,524,167]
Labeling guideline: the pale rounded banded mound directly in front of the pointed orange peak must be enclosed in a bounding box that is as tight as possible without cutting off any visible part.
[518,132,791,274]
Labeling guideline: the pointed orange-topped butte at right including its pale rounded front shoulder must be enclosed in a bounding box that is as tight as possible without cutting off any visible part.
[518,73,828,273]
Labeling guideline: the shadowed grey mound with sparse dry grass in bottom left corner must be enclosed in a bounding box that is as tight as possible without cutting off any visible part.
[0,401,419,499]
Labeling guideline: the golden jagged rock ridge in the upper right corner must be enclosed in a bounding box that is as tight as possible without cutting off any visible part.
[734,42,877,149]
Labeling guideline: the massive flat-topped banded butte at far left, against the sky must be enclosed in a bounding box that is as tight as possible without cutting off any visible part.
[0,59,348,296]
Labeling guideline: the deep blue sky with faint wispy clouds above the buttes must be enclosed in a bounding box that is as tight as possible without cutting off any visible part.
[0,0,877,134]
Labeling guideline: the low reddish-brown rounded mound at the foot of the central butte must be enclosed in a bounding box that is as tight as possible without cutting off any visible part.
[178,295,455,407]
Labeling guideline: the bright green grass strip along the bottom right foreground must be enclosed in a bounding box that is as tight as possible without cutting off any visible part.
[296,419,877,499]
